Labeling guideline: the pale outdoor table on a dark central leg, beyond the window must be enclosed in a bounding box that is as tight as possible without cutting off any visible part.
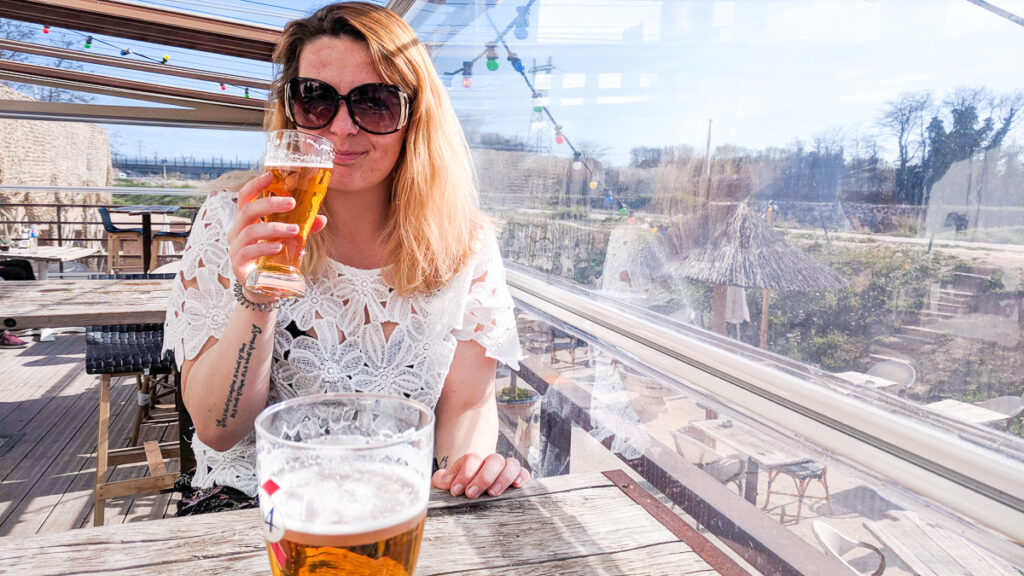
[690,418,810,505]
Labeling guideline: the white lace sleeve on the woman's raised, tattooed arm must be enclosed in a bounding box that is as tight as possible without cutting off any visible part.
[164,192,236,368]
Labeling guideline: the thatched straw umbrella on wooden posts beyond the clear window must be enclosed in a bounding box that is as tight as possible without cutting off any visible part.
[681,204,846,347]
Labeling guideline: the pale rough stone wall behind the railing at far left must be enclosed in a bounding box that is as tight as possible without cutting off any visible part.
[0,84,113,239]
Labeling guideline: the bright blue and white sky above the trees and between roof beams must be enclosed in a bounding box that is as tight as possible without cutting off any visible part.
[8,0,1024,164]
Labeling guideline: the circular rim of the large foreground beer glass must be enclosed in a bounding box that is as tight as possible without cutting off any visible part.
[254,393,434,453]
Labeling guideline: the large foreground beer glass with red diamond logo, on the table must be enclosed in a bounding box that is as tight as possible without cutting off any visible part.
[256,394,434,576]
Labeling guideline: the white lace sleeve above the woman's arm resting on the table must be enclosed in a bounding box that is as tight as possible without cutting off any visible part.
[455,231,522,370]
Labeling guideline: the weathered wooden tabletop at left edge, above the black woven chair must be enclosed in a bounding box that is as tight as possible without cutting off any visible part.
[0,280,173,330]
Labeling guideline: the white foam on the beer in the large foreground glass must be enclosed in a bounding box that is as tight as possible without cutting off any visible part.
[273,462,430,537]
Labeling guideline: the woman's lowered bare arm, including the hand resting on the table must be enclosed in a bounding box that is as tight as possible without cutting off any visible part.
[433,340,529,498]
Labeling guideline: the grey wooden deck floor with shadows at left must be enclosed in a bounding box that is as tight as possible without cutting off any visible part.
[0,334,178,536]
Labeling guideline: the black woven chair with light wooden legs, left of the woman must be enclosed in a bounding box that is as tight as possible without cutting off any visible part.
[85,274,181,526]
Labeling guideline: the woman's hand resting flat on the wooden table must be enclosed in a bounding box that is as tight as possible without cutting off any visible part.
[431,452,529,498]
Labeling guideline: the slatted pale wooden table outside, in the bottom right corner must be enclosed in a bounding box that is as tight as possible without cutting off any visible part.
[864,511,1020,576]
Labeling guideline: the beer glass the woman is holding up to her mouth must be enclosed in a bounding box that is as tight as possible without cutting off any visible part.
[246,130,334,298]
